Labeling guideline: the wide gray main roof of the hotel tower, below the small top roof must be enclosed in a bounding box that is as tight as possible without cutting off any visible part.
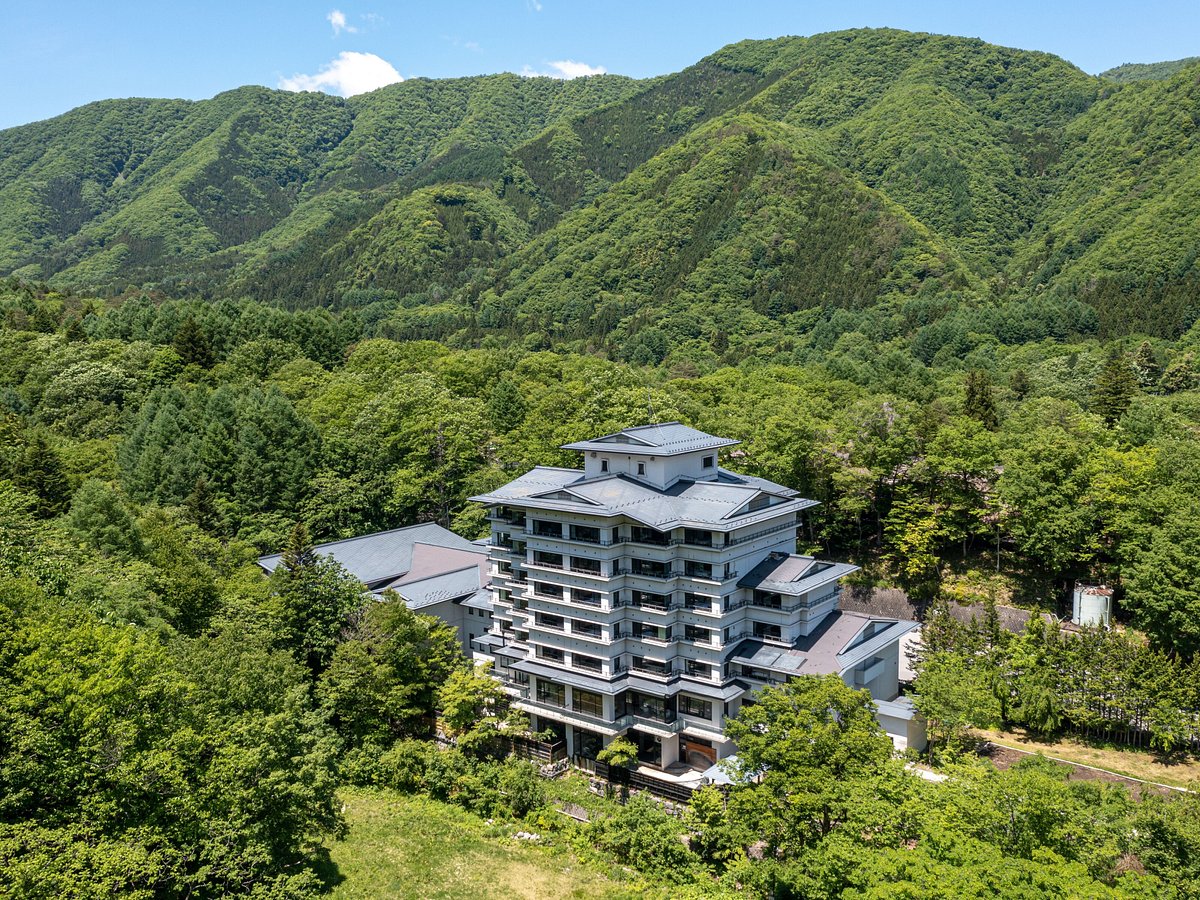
[472,466,816,530]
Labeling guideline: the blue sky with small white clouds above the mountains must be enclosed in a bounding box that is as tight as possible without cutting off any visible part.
[0,0,1200,127]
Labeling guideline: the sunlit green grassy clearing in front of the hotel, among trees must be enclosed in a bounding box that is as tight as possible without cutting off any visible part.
[319,788,635,900]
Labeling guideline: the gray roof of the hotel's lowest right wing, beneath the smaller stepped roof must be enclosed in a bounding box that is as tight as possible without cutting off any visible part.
[732,610,917,676]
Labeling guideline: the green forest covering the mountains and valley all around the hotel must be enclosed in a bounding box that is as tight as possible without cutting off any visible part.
[0,30,1200,899]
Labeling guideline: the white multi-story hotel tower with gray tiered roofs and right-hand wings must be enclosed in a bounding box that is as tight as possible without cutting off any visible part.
[474,422,917,768]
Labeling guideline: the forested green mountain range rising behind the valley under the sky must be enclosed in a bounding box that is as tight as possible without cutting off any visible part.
[0,30,1200,340]
